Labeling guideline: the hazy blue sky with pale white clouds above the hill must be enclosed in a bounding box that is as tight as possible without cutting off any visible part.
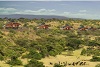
[0,0,100,19]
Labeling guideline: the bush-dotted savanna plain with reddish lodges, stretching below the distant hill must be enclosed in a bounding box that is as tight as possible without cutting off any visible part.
[0,17,100,67]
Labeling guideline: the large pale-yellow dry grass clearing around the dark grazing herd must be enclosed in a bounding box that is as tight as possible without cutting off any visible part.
[40,49,100,67]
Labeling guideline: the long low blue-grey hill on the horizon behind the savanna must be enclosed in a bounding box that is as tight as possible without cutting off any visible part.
[0,14,69,19]
